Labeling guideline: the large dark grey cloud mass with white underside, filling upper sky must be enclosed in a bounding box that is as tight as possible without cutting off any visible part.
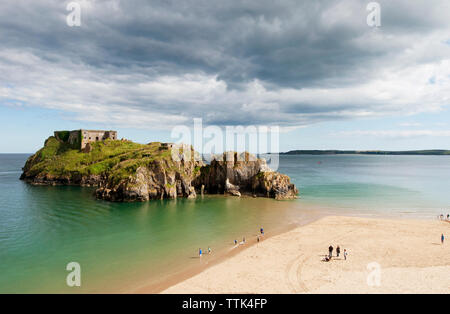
[0,0,449,127]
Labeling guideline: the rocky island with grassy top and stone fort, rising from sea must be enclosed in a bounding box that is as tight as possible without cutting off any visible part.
[20,130,298,201]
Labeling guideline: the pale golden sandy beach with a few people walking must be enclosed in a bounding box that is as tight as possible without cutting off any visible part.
[162,216,450,294]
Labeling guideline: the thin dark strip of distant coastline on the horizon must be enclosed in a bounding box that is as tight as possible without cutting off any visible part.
[280,149,450,156]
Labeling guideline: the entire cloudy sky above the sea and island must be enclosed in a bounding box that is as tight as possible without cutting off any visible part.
[0,0,450,152]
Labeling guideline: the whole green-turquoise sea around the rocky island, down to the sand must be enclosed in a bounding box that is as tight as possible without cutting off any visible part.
[0,154,450,293]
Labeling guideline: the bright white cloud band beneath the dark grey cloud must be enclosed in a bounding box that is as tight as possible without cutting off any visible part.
[0,46,450,128]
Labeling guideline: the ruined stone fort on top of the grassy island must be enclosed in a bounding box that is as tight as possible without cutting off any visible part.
[54,129,117,149]
